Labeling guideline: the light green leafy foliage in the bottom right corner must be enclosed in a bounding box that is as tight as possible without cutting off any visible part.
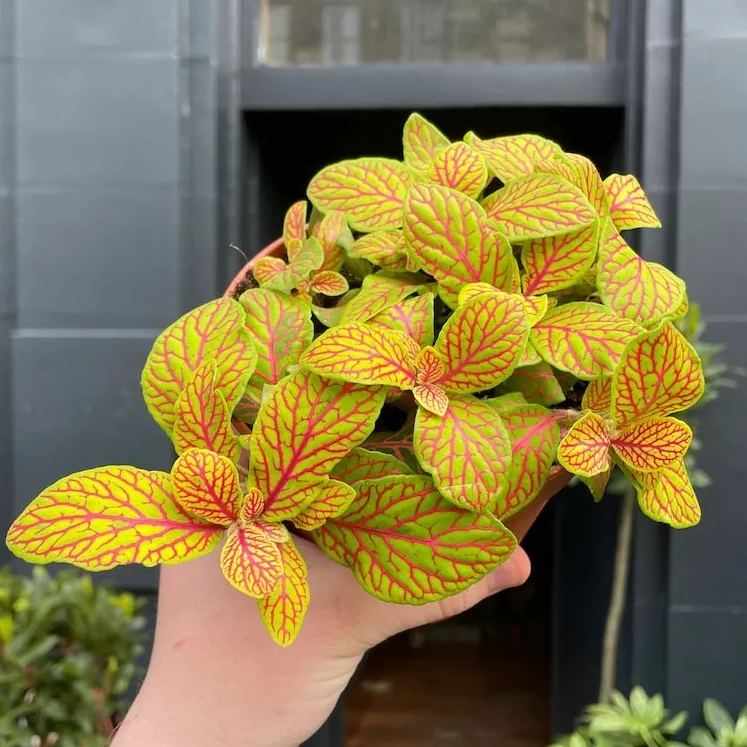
[551,687,747,747]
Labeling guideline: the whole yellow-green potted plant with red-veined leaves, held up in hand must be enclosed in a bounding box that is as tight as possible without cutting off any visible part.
[8,114,703,645]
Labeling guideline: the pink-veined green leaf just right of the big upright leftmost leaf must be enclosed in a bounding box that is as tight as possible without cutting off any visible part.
[239,288,314,407]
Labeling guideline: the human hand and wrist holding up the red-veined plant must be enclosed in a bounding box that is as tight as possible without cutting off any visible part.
[113,478,565,747]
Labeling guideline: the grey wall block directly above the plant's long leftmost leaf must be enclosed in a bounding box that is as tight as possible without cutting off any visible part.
[12,330,172,509]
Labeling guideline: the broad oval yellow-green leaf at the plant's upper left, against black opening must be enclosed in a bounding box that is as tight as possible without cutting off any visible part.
[308,158,416,231]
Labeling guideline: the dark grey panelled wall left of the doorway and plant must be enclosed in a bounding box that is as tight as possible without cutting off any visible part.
[0,0,225,587]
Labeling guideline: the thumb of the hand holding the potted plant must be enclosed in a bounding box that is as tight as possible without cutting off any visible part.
[364,547,531,645]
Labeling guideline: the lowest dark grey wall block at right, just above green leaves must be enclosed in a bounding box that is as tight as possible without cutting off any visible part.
[667,609,747,719]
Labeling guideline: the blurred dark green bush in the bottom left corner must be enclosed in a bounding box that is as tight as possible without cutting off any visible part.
[0,568,145,747]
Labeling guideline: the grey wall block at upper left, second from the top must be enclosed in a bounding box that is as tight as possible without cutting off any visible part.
[17,58,179,188]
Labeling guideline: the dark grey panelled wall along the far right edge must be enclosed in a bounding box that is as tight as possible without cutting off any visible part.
[667,0,747,709]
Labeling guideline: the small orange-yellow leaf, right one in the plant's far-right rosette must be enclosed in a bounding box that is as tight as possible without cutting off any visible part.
[612,416,693,472]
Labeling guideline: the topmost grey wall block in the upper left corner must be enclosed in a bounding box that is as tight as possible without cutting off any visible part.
[16,0,178,58]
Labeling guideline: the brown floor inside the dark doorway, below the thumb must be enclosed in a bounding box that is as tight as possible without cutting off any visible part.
[345,629,550,747]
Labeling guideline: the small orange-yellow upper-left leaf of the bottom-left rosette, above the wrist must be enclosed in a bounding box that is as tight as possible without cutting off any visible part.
[171,449,241,526]
